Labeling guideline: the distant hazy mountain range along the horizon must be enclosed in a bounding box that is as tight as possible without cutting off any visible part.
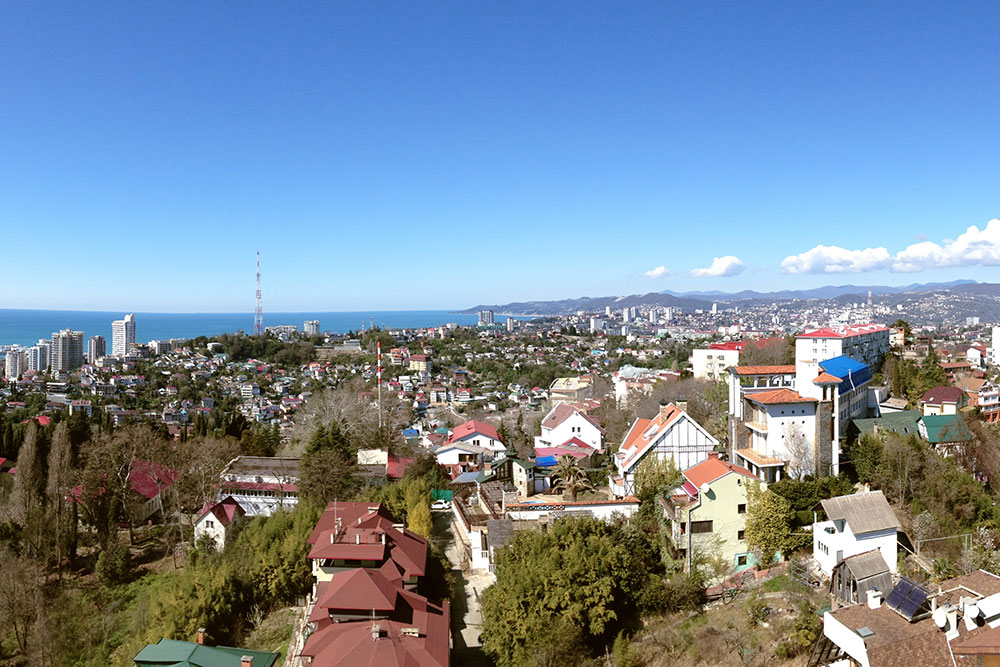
[458,280,984,316]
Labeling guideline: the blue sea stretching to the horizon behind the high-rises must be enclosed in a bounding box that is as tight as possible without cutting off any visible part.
[0,308,529,350]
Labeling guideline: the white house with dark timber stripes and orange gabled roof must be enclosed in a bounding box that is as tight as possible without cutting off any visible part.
[610,403,719,498]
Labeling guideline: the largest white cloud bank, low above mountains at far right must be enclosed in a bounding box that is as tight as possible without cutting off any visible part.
[781,218,1000,273]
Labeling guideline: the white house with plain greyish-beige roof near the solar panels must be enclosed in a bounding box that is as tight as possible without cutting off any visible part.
[813,491,901,577]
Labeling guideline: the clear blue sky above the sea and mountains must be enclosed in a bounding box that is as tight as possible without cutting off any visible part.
[0,1,1000,312]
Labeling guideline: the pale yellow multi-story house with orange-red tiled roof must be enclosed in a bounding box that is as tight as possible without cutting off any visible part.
[660,452,757,572]
